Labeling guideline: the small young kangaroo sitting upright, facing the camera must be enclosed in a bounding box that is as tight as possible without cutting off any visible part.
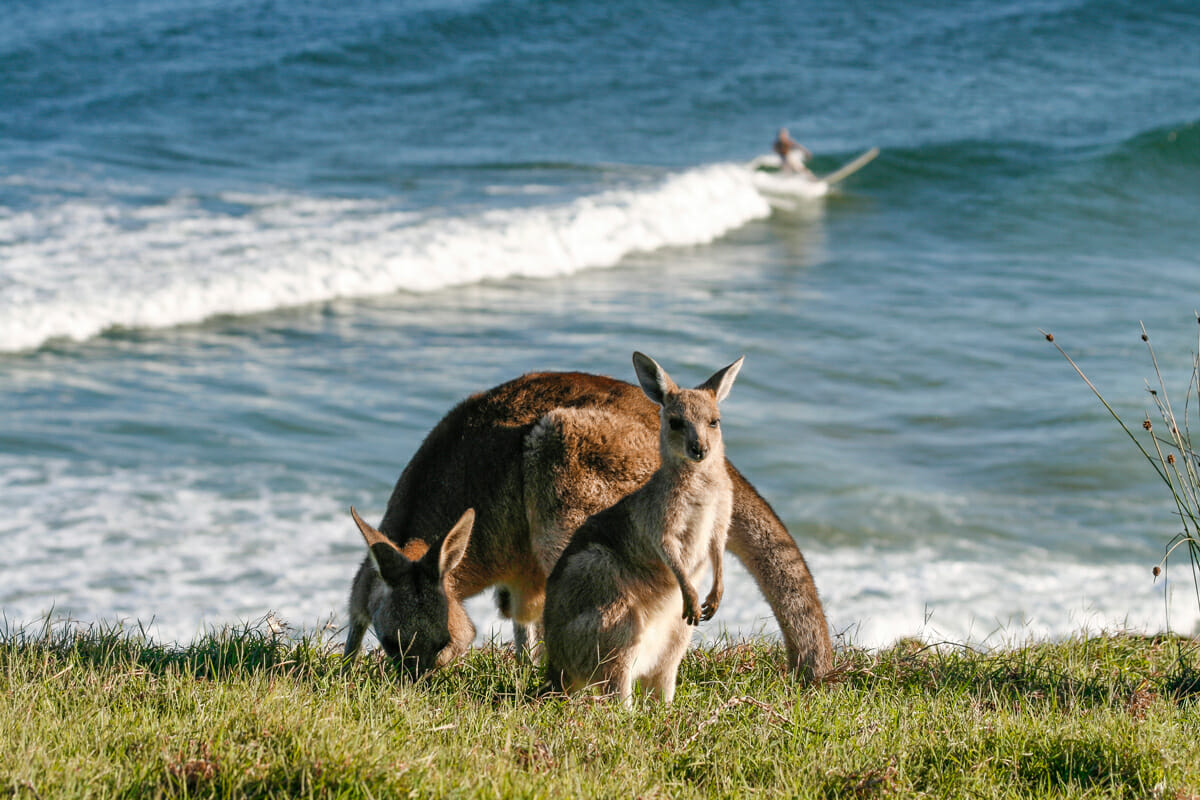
[542,353,744,705]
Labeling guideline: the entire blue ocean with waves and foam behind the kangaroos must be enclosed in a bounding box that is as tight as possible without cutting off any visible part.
[0,0,1200,646]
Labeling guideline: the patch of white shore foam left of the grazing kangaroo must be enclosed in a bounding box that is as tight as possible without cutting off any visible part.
[0,459,361,642]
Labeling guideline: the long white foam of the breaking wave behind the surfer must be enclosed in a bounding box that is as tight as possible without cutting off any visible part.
[0,164,770,351]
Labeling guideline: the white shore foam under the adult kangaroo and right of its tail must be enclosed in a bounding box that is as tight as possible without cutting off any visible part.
[468,547,1200,648]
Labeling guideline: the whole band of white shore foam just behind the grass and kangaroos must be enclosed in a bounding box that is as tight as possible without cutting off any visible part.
[7,458,1200,646]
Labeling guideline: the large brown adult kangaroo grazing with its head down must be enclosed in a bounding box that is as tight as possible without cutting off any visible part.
[346,372,833,681]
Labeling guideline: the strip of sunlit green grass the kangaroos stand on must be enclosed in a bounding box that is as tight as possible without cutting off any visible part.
[0,626,1200,799]
